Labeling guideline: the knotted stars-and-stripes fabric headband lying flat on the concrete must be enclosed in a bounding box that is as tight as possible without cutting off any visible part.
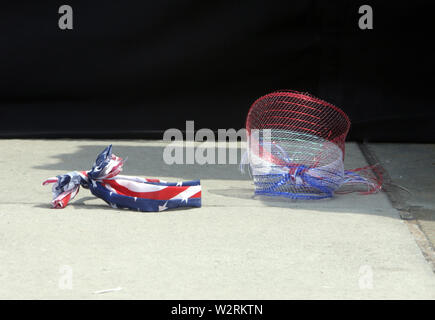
[43,145,201,211]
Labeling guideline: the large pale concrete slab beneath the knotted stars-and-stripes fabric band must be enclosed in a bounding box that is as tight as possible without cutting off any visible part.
[0,140,435,299]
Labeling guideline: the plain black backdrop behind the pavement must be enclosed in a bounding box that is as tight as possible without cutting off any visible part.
[0,0,435,142]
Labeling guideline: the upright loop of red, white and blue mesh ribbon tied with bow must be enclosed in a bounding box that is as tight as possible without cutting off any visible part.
[246,90,382,199]
